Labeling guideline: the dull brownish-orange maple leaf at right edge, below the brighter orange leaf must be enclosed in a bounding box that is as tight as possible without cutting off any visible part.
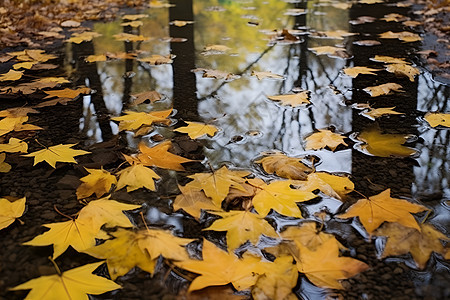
[375,223,450,269]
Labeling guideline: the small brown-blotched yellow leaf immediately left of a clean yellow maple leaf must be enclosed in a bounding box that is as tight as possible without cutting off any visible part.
[77,168,117,199]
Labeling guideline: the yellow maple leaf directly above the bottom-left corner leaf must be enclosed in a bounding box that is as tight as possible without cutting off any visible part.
[23,219,108,259]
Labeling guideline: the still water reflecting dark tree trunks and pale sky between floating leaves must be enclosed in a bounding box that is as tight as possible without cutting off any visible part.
[0,0,450,299]
